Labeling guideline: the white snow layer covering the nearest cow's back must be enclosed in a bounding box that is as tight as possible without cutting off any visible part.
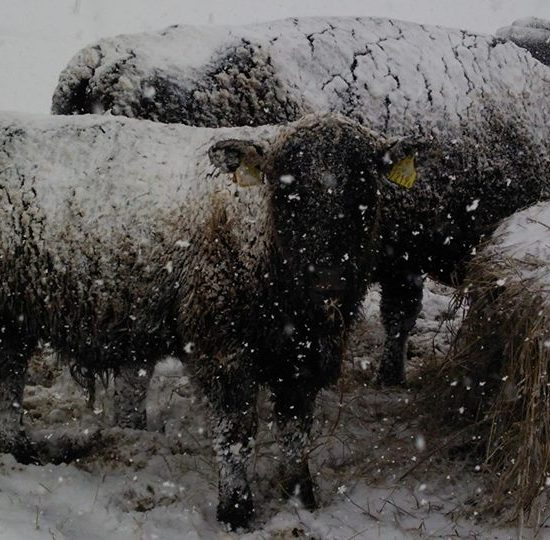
[0,113,276,245]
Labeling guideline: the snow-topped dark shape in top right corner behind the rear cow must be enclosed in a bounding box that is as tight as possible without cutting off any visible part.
[497,17,550,66]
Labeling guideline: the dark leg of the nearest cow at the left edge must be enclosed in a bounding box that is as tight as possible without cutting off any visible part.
[0,347,39,463]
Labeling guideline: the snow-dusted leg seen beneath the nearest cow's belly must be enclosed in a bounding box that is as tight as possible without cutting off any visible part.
[114,362,155,429]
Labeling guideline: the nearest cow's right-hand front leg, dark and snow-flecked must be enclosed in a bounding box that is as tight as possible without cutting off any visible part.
[273,381,317,510]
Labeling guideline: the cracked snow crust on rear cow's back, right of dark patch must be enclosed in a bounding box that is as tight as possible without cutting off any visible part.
[272,17,550,135]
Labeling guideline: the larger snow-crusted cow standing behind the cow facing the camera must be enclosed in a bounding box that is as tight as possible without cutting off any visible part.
[52,18,550,384]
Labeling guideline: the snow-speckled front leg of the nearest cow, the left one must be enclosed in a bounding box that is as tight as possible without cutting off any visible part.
[213,379,258,529]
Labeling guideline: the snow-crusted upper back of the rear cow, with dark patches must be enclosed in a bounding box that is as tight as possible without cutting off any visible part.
[52,17,548,134]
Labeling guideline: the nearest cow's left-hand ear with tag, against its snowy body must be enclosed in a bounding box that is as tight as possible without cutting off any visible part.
[208,139,265,187]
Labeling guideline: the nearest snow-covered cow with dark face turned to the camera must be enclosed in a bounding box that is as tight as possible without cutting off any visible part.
[0,110,387,526]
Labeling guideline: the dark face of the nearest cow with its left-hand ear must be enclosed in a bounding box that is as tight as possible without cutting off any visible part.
[210,115,398,314]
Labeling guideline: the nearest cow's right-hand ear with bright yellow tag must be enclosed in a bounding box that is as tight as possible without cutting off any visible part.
[378,137,427,189]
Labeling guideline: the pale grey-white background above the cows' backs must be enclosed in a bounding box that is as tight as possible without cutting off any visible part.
[0,0,550,112]
